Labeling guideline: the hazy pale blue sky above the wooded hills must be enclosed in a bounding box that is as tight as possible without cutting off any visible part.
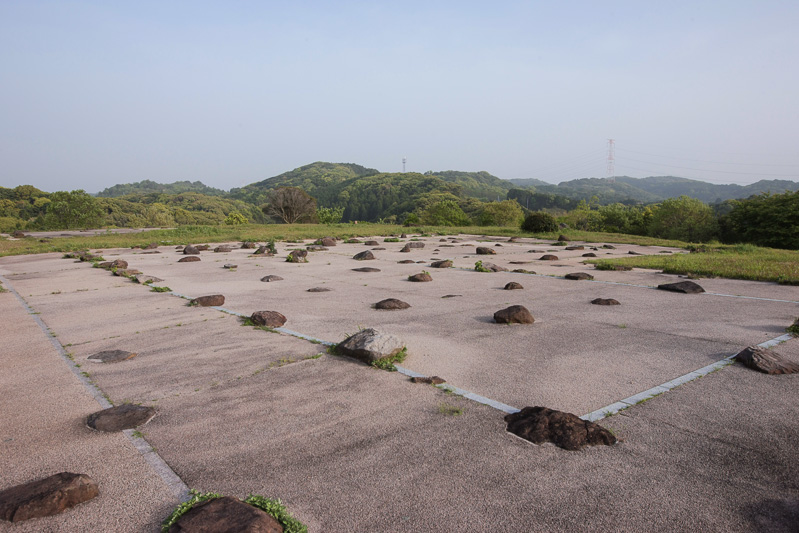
[0,0,799,192]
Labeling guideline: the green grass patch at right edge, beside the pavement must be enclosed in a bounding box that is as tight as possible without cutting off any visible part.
[586,244,799,285]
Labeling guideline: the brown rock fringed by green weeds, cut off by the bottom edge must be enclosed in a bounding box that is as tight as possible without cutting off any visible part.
[169,496,283,533]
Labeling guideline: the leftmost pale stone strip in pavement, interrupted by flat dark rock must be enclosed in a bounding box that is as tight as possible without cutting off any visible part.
[0,276,189,501]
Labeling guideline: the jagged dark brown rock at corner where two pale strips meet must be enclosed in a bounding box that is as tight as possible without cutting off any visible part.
[505,407,616,451]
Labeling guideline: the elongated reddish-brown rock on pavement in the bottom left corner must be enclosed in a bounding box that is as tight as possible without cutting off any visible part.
[0,472,100,522]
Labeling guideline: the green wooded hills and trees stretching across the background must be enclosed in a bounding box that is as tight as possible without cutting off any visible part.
[0,162,799,249]
